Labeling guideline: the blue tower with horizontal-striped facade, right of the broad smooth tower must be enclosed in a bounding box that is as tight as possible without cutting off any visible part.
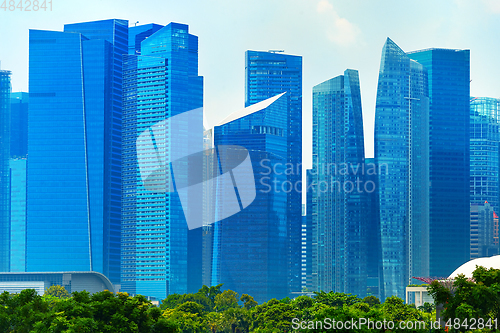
[122,23,203,300]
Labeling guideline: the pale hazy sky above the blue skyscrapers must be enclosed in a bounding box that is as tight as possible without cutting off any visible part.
[0,0,500,167]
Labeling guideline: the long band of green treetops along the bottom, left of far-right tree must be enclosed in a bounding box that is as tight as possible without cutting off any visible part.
[0,285,438,333]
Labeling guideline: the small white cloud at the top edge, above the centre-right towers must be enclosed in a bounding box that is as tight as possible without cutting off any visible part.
[316,0,361,46]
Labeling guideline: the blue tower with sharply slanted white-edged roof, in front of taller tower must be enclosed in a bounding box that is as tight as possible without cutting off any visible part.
[212,93,290,303]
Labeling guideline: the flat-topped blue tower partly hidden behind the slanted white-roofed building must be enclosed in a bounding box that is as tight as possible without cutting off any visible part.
[245,51,302,292]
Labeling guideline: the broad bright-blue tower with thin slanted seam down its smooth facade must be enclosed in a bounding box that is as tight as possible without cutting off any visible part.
[26,19,128,283]
